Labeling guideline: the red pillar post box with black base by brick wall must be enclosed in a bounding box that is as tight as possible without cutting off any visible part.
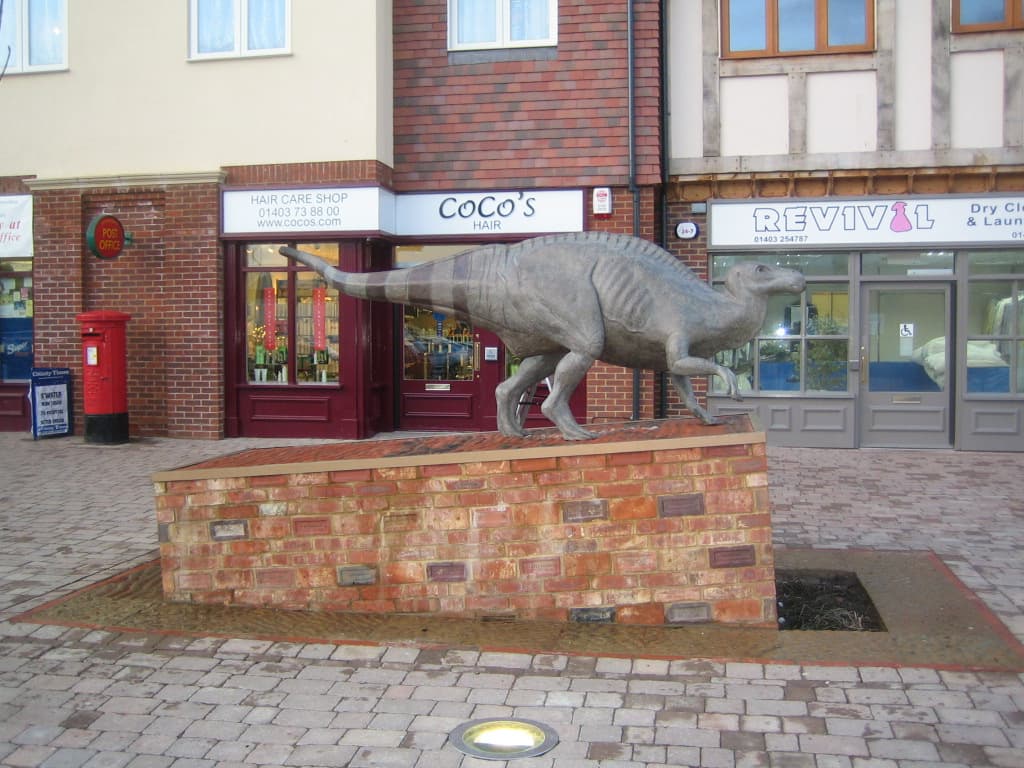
[76,309,131,443]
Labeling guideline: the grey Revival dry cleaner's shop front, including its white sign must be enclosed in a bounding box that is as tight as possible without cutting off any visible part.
[709,196,1024,451]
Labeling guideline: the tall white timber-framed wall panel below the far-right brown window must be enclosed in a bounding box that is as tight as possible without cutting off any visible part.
[949,50,1005,147]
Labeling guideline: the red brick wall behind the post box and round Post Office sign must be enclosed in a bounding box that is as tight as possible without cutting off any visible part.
[33,183,223,437]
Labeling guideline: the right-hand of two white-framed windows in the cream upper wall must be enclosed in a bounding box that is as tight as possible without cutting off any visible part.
[188,0,292,58]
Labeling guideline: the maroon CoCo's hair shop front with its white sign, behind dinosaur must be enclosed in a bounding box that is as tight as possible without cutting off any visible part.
[222,187,586,438]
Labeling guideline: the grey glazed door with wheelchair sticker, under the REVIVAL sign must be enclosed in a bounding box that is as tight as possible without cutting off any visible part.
[860,284,956,447]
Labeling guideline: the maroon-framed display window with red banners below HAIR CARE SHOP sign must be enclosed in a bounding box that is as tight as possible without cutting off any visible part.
[225,242,393,438]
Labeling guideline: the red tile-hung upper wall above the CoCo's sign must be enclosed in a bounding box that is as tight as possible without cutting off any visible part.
[394,0,659,190]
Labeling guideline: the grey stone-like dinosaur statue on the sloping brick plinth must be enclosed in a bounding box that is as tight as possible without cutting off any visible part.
[281,232,804,440]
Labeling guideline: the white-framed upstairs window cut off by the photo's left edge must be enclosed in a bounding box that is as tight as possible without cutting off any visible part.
[0,0,68,74]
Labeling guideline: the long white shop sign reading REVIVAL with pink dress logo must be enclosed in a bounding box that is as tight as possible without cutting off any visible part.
[708,196,1024,250]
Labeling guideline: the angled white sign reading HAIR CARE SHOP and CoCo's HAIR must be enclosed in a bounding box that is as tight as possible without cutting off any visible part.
[222,186,584,237]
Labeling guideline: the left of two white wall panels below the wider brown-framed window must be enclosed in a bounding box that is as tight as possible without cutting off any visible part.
[720,75,790,157]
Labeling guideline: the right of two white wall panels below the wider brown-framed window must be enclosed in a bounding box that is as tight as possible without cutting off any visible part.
[807,72,878,155]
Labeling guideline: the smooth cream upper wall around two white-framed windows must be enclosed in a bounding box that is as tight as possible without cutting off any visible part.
[0,0,393,178]
